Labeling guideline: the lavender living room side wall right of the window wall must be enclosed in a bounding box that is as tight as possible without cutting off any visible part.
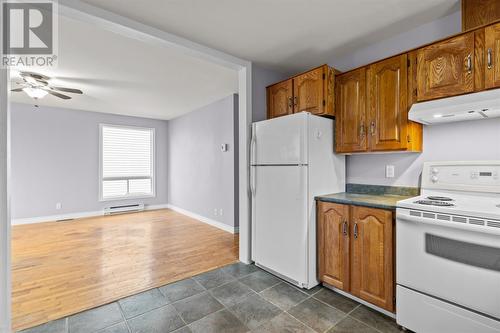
[167,95,238,227]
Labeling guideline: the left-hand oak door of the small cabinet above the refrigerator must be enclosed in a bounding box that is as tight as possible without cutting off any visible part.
[267,79,293,119]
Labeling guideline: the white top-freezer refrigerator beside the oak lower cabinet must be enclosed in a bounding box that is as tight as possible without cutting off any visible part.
[250,112,345,289]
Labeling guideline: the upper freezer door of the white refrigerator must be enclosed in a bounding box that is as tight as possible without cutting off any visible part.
[251,112,309,165]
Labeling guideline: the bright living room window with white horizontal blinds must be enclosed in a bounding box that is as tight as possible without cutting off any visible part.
[100,125,155,200]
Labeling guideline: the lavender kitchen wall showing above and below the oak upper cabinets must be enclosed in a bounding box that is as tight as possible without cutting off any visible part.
[329,7,500,186]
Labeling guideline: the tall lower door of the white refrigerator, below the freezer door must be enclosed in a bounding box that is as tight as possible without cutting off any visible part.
[252,166,308,286]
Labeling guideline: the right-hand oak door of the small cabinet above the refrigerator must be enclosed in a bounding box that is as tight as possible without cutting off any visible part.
[293,67,326,115]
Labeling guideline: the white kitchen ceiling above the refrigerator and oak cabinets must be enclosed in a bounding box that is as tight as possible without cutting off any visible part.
[83,0,460,72]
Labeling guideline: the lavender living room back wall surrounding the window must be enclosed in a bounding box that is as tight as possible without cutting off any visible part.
[11,103,167,219]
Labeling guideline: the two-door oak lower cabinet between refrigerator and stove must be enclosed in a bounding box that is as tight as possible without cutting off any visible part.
[317,201,395,312]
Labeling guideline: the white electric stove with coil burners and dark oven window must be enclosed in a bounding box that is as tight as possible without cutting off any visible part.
[396,161,500,333]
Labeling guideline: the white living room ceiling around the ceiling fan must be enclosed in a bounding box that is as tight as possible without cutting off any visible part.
[11,17,238,119]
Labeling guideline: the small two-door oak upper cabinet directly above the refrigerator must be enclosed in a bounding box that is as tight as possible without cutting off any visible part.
[267,65,335,118]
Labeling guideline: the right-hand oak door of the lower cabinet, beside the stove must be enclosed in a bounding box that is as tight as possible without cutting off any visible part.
[351,206,394,311]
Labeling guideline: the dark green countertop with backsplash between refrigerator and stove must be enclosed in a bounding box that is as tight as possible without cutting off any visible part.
[315,185,418,210]
